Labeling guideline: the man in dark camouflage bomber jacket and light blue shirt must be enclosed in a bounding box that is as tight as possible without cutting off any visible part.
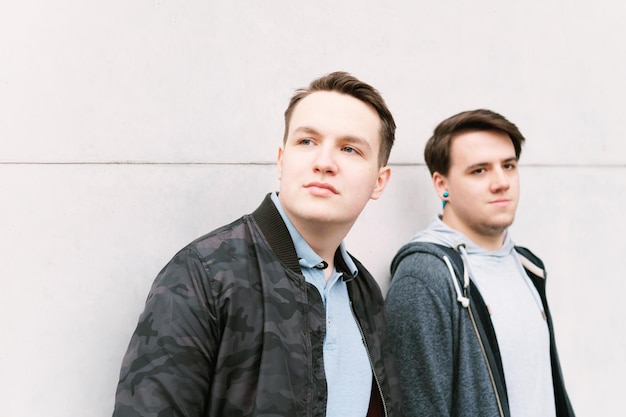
[113,72,400,417]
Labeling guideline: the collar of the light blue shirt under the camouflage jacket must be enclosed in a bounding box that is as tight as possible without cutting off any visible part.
[271,192,358,281]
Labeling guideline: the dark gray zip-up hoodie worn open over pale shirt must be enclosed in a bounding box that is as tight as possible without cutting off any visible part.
[386,220,574,417]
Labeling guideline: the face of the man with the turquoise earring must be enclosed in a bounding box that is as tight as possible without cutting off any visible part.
[433,131,519,245]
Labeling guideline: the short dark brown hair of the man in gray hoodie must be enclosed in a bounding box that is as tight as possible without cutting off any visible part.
[424,109,525,176]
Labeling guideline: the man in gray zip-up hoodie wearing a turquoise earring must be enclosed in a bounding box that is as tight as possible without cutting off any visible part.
[386,110,574,417]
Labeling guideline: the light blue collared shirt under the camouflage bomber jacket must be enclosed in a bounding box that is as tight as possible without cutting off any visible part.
[271,193,372,417]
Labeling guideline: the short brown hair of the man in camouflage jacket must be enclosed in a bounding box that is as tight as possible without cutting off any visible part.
[283,71,396,166]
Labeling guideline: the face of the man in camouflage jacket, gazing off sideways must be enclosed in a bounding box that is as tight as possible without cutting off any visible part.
[278,91,389,233]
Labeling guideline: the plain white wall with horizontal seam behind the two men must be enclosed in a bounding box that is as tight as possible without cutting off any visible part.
[0,0,626,417]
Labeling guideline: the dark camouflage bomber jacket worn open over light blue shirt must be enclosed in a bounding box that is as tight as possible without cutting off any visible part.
[113,195,399,417]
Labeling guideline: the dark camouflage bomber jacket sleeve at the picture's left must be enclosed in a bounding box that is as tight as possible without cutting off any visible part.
[113,248,219,417]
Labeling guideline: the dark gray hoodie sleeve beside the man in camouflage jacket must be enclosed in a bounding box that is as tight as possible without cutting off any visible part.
[385,253,456,417]
